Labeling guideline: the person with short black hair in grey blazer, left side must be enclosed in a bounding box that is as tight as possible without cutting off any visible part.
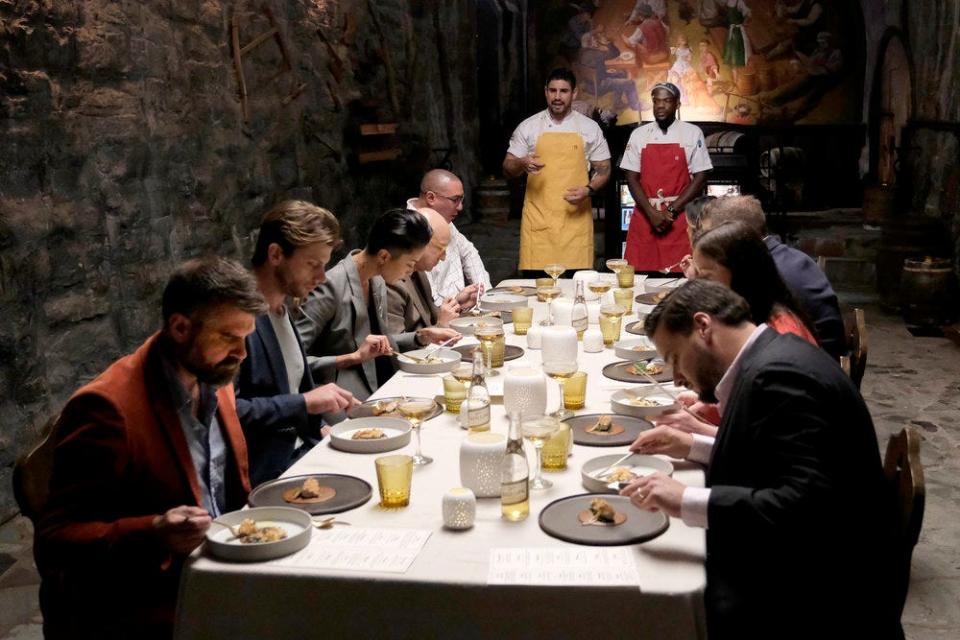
[297,209,460,422]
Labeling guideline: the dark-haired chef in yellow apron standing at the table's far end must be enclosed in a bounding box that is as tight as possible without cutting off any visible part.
[503,69,610,270]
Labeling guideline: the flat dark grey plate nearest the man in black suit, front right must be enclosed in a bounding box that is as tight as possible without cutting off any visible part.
[540,493,670,547]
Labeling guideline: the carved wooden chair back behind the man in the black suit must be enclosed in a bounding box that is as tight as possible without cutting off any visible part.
[883,427,926,618]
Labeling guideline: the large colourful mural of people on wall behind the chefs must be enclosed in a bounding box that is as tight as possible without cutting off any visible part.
[556,0,863,124]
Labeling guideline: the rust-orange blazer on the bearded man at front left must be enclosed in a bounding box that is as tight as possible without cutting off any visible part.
[35,334,250,637]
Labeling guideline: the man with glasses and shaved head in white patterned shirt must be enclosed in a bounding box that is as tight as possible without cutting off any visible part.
[407,169,491,306]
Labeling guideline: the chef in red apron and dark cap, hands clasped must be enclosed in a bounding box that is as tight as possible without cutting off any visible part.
[620,82,713,272]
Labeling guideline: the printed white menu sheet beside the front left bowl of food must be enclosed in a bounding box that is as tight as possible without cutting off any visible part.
[275,527,431,573]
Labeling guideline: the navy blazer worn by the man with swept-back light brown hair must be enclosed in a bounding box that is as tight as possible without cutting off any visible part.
[234,313,323,486]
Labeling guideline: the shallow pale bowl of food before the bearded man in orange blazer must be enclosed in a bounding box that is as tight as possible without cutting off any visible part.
[207,507,313,562]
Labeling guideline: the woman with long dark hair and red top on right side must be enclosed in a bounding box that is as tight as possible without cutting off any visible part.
[693,222,817,345]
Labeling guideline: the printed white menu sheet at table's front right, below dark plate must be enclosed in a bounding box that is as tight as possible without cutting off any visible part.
[487,547,640,587]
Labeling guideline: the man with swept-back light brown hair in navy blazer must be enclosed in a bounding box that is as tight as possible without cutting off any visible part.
[235,200,357,486]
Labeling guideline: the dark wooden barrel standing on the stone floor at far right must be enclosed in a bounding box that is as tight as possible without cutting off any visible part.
[900,257,957,327]
